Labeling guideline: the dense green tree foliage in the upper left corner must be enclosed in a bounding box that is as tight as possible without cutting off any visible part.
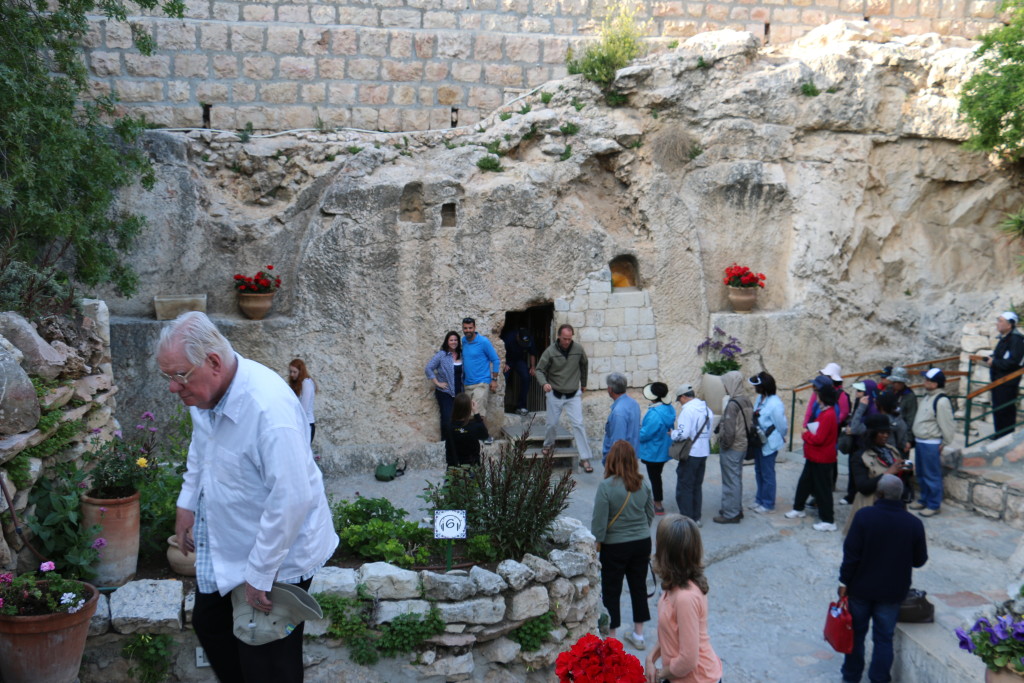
[0,0,183,313]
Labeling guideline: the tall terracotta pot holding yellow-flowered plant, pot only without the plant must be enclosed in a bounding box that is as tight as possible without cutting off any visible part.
[82,492,139,588]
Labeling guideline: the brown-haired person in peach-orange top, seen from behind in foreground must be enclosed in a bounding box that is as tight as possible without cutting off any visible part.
[644,515,722,683]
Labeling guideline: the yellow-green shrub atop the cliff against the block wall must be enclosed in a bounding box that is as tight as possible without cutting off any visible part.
[565,0,646,88]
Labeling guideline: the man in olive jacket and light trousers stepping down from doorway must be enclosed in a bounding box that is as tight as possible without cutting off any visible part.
[535,325,594,472]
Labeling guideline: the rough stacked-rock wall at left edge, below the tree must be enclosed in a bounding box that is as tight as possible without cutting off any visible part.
[0,299,119,571]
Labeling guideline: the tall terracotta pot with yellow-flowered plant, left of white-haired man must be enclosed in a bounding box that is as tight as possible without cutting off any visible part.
[81,411,158,587]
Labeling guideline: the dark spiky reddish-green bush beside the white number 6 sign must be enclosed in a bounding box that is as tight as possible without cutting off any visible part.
[423,437,575,559]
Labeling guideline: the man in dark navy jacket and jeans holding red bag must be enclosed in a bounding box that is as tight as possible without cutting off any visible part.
[839,474,928,683]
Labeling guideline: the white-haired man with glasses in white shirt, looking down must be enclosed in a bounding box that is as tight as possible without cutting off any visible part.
[157,311,338,683]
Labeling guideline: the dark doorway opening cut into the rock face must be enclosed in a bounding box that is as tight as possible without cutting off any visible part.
[501,303,555,413]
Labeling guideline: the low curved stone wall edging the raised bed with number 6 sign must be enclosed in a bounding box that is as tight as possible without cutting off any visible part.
[80,517,600,683]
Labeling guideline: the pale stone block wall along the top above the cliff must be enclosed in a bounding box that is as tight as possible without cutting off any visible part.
[87,0,999,131]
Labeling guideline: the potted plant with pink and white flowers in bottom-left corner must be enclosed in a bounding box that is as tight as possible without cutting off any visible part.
[0,562,99,683]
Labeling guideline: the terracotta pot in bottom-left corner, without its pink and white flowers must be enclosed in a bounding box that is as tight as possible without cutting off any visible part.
[0,584,99,683]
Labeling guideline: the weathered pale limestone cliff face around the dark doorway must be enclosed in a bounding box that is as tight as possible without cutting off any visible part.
[110,23,1024,462]
